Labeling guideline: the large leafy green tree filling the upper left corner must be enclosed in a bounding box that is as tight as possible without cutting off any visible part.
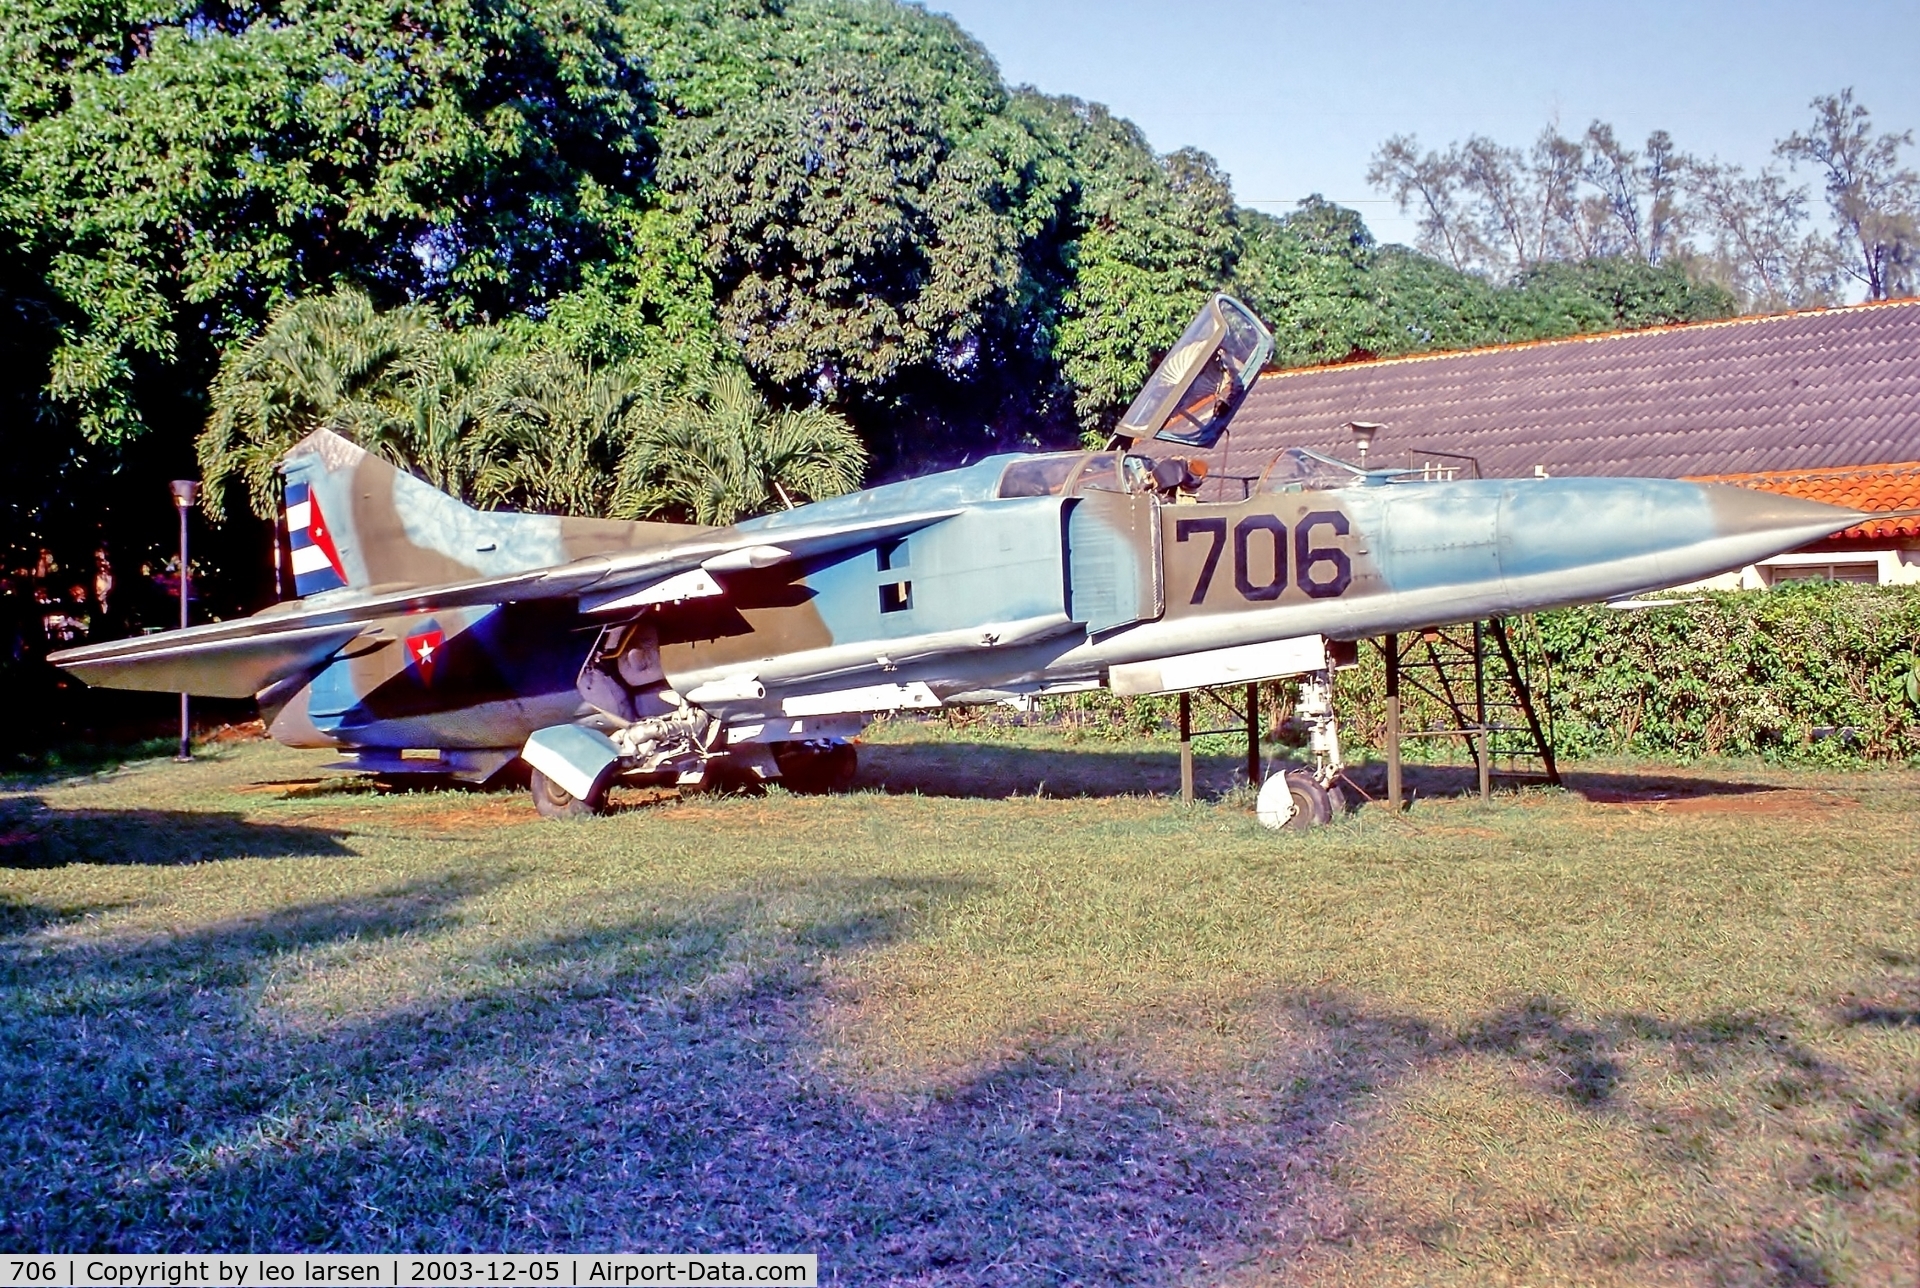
[0,0,645,441]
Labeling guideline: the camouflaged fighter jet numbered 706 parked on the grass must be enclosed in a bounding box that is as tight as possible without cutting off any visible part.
[52,296,1862,822]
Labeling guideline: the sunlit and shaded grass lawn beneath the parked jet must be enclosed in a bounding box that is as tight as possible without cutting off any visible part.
[0,726,1920,1286]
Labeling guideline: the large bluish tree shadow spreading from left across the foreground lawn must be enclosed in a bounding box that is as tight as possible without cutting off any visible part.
[0,875,1904,1286]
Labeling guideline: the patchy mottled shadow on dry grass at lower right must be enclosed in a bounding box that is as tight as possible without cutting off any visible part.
[1275,994,1920,1288]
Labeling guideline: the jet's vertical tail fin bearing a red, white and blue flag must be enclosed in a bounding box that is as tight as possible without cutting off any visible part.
[280,430,574,599]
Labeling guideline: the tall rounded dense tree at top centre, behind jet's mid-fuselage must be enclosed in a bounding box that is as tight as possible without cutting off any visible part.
[636,0,1031,412]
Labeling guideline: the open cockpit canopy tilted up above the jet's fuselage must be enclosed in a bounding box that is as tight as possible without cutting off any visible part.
[1114,296,1273,447]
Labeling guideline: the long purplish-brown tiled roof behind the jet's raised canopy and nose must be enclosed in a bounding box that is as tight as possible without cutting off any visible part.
[1215,299,1920,478]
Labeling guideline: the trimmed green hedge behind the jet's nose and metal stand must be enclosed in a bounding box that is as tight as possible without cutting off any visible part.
[1006,584,1920,764]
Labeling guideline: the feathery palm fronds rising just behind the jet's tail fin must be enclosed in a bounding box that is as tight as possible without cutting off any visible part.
[198,290,866,524]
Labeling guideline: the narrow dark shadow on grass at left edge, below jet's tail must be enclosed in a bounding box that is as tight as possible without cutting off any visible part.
[0,797,353,870]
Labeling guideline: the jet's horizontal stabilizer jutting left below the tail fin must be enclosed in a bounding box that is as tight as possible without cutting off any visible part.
[48,622,365,697]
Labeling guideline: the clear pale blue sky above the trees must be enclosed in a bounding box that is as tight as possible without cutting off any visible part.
[927,0,1920,242]
